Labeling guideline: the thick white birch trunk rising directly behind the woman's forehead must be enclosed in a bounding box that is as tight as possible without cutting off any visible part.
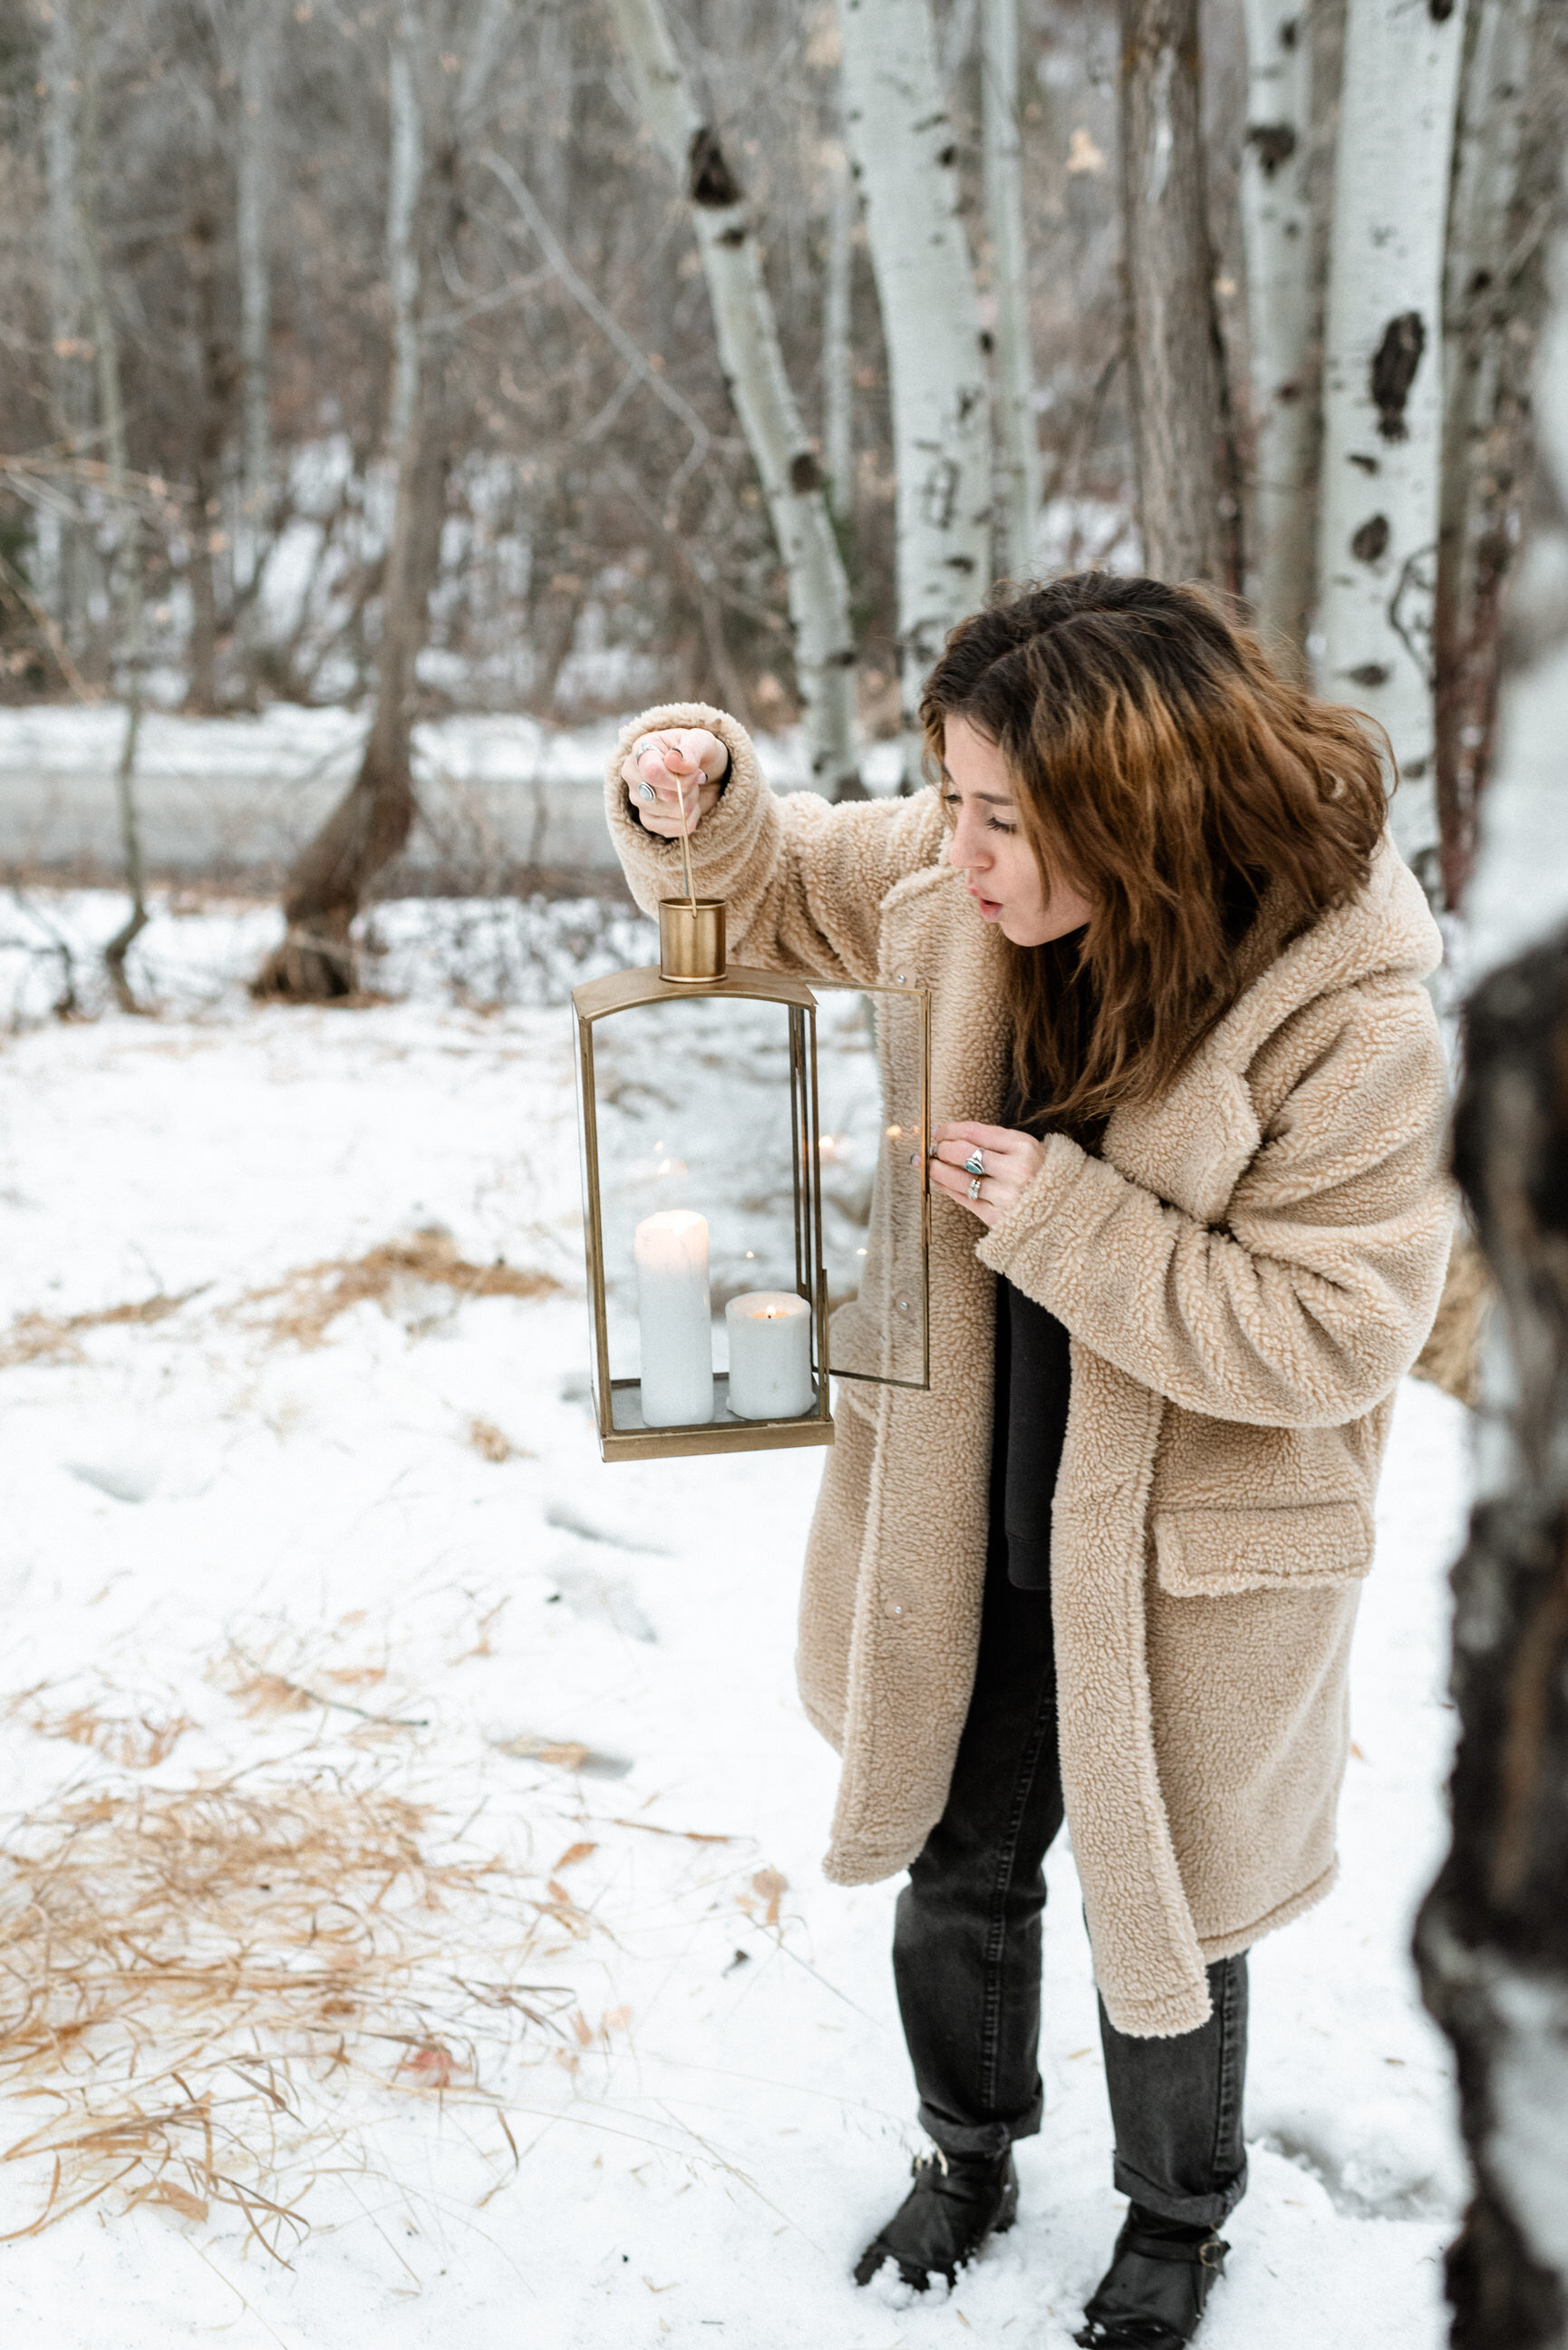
[837,0,992,790]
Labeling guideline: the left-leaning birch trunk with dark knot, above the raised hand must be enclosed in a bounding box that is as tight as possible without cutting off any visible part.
[611,0,863,799]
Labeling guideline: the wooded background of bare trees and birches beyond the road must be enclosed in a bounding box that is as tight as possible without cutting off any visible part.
[0,0,1568,958]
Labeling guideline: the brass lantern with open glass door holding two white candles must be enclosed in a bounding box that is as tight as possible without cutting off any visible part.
[571,896,931,1461]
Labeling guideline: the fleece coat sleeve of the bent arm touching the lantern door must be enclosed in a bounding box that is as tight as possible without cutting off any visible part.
[978,987,1453,1429]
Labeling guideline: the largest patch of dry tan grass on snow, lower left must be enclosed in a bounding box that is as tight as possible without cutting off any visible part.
[0,1777,576,2258]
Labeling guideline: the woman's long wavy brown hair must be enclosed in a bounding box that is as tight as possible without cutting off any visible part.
[919,571,1385,1126]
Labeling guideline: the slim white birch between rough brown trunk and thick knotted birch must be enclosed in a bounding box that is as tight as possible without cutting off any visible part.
[1241,0,1321,648]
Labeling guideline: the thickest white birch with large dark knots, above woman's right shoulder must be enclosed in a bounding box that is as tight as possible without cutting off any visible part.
[1319,0,1465,886]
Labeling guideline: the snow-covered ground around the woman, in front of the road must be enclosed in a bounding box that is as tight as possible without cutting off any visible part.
[0,898,1466,2350]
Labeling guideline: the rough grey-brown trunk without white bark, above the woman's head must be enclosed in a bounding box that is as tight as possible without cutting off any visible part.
[1121,0,1234,585]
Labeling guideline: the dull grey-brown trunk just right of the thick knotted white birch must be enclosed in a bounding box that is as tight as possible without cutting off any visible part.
[1434,0,1563,908]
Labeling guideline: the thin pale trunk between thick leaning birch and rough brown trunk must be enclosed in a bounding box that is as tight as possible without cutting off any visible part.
[981,0,1041,578]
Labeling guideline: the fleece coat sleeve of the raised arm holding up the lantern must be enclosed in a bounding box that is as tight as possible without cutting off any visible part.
[605,703,943,985]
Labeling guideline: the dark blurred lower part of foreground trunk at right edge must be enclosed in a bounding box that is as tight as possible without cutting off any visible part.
[1415,930,1568,2350]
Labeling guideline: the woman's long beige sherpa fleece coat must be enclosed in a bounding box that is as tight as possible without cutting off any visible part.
[606,703,1450,2035]
